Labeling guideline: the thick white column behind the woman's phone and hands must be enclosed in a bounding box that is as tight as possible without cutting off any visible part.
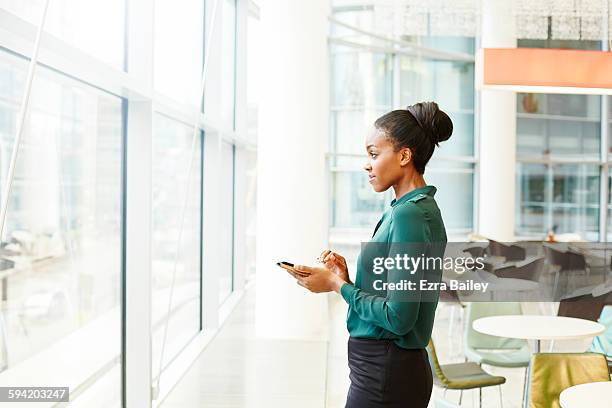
[256,0,329,339]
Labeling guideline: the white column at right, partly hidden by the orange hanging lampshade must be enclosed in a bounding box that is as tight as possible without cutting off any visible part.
[478,0,516,241]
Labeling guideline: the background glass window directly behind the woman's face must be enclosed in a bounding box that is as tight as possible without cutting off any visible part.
[330,46,393,228]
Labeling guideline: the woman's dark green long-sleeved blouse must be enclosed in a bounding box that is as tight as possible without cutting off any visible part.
[340,185,447,349]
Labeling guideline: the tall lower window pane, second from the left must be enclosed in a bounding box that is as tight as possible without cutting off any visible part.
[151,114,202,377]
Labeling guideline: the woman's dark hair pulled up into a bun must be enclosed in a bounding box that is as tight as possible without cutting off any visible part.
[374,102,453,174]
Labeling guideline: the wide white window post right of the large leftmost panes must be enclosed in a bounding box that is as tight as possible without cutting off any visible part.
[124,0,154,408]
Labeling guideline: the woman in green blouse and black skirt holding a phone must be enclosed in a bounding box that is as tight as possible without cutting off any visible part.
[294,102,453,408]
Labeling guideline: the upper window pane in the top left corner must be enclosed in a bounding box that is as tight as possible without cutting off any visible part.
[0,0,126,69]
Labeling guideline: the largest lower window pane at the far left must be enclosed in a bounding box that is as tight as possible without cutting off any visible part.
[0,52,122,406]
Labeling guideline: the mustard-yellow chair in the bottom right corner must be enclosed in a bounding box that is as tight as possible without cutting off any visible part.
[525,353,610,408]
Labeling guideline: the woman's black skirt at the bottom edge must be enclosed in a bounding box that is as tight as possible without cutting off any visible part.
[346,337,433,408]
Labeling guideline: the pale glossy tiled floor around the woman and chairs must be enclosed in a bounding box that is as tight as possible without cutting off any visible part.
[162,286,586,408]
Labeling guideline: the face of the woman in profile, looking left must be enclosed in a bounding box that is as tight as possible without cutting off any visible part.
[363,129,411,193]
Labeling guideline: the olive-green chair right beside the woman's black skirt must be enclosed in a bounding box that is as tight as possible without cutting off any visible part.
[427,340,506,407]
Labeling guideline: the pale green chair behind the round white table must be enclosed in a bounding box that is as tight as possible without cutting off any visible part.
[463,302,531,395]
